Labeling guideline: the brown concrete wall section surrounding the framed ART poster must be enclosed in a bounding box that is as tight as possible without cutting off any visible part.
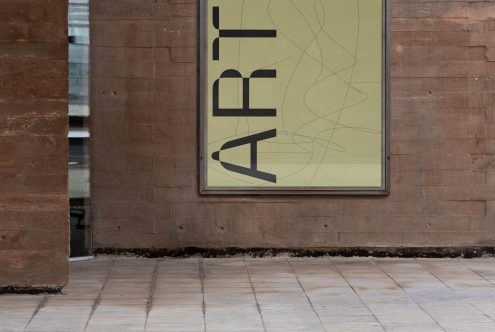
[91,0,495,248]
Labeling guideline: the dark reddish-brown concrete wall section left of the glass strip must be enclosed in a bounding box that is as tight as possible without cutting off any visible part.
[0,0,69,287]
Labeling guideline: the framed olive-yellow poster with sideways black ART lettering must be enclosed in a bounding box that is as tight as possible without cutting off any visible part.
[199,0,389,195]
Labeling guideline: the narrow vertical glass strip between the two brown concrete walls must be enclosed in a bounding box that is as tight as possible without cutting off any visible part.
[68,0,91,257]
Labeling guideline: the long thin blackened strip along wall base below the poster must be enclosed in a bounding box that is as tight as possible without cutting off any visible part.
[93,247,495,258]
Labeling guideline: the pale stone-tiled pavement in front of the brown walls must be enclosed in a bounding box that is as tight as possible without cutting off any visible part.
[0,257,495,332]
